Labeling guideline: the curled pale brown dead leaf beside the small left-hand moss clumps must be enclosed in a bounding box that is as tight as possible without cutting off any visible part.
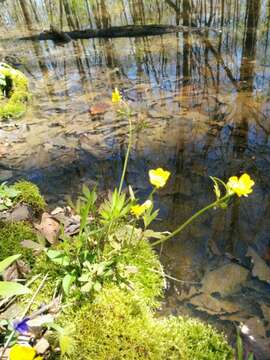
[35,213,60,245]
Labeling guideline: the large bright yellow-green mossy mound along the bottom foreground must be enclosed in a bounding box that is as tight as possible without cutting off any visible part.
[60,286,233,360]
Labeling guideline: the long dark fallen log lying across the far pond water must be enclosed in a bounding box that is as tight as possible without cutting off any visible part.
[19,25,207,42]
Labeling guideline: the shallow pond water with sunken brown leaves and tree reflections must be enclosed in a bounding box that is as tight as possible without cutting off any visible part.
[0,0,270,359]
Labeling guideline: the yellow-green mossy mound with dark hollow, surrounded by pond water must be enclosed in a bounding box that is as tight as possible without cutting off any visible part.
[0,63,30,118]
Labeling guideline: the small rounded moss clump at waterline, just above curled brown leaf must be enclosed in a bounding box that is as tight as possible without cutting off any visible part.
[14,181,46,214]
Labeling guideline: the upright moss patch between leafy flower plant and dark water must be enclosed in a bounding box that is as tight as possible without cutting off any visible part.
[120,240,164,307]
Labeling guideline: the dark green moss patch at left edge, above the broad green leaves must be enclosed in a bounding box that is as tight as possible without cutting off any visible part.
[0,222,37,264]
